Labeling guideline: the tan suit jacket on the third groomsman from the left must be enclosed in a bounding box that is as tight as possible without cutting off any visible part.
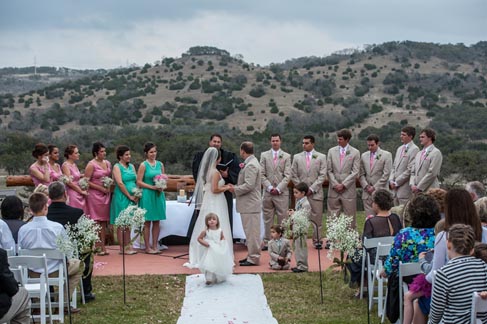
[327,145,360,199]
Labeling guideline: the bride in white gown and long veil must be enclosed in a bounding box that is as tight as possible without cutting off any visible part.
[184,147,233,268]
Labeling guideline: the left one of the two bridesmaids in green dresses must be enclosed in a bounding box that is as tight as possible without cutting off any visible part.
[110,145,138,254]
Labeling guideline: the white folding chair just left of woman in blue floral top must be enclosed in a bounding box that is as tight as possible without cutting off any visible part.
[369,242,392,317]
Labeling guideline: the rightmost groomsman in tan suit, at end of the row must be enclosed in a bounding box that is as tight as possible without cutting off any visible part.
[409,128,443,193]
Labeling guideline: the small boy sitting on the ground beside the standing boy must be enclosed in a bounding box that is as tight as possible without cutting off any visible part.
[268,225,291,270]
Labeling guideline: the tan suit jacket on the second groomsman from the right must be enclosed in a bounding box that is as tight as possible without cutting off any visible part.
[389,141,419,204]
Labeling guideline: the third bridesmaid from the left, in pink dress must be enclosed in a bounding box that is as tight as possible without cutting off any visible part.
[61,144,88,212]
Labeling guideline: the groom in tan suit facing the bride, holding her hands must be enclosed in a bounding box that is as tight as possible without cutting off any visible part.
[230,142,262,266]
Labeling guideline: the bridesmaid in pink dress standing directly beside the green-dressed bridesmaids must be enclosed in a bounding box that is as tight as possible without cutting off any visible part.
[85,142,112,256]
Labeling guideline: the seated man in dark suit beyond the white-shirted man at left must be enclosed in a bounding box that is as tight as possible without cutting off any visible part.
[47,181,95,301]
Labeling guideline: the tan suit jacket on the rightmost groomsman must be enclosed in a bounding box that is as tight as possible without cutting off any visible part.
[409,144,443,191]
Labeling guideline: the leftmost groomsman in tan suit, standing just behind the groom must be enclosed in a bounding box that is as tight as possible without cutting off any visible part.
[260,134,291,251]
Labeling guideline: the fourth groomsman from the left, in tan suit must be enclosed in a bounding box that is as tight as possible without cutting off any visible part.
[360,134,392,216]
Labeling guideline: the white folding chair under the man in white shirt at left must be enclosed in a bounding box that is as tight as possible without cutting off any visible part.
[19,248,70,323]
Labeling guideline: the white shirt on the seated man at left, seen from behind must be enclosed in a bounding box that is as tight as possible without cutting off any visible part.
[18,216,66,273]
